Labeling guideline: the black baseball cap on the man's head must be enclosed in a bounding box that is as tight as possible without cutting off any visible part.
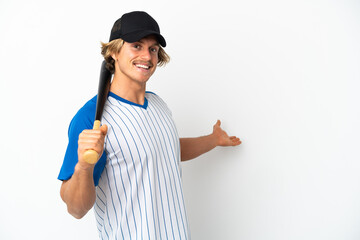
[109,11,166,47]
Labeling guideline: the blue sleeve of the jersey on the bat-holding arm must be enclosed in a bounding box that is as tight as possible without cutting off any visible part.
[58,97,106,186]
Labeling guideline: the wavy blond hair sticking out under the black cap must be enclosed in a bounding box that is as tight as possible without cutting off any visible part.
[101,38,170,73]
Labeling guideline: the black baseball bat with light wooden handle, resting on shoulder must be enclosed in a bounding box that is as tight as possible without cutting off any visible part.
[83,61,112,164]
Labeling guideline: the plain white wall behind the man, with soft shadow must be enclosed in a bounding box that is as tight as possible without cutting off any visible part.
[0,0,360,240]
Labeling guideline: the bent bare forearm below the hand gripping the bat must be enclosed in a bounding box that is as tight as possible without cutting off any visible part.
[60,164,96,219]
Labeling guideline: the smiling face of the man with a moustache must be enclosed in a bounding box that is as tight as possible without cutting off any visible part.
[112,36,160,84]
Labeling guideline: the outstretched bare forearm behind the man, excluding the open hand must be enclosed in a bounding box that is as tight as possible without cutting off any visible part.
[180,134,217,161]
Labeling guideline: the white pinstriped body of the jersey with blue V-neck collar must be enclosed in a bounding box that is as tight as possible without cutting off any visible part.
[94,92,189,240]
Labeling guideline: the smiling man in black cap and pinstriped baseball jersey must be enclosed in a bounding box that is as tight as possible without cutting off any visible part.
[58,12,241,239]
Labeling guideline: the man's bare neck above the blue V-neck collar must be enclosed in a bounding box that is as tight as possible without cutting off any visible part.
[110,72,146,105]
